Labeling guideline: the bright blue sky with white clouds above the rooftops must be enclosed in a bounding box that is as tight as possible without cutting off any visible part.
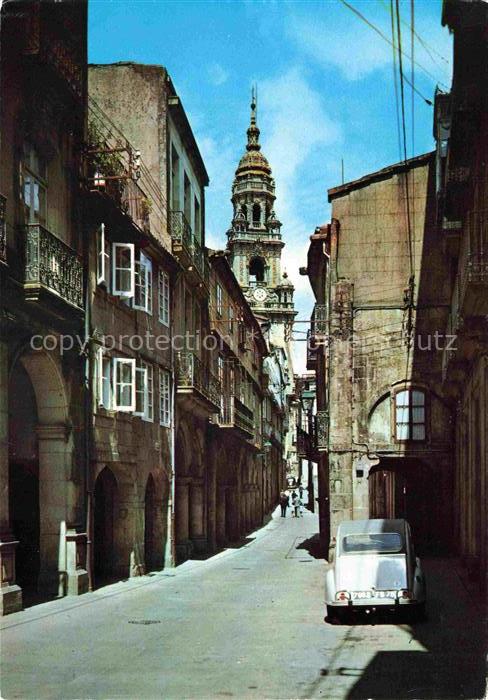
[89,0,452,370]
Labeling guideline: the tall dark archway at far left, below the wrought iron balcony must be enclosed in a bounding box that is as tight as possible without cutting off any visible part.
[9,363,41,603]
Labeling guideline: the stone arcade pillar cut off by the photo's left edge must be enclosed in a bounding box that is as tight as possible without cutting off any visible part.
[0,339,22,615]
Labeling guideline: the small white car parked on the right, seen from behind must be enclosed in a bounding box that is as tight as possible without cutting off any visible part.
[325,520,426,618]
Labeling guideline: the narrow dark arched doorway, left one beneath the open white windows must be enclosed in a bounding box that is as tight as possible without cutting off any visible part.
[93,467,117,586]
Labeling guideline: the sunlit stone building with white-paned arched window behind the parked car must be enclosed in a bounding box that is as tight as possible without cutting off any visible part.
[308,154,454,551]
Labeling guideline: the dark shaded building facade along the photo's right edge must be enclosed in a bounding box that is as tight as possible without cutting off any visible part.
[434,0,488,593]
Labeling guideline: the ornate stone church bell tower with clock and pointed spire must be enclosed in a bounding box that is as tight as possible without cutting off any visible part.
[227,89,297,350]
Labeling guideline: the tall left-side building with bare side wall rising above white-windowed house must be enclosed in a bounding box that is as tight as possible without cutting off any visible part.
[89,63,220,561]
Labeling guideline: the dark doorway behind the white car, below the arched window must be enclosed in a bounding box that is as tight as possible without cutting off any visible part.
[369,457,435,551]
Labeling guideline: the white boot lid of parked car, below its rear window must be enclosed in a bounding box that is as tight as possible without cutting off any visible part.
[335,554,408,591]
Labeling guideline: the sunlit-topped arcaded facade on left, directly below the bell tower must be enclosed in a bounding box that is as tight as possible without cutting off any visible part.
[209,251,283,546]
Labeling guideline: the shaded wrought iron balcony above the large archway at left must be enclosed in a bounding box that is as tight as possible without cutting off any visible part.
[24,224,83,310]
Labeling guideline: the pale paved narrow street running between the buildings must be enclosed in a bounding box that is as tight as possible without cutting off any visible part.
[2,513,484,698]
